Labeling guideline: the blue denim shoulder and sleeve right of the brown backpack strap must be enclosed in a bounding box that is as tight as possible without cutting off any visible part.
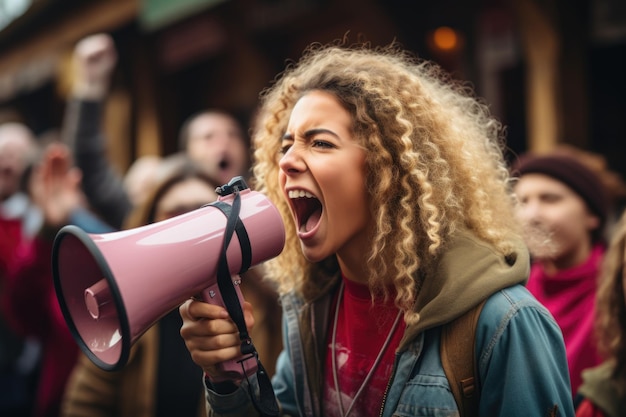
[476,285,574,416]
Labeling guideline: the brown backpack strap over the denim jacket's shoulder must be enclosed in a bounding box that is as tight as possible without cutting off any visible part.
[440,300,486,417]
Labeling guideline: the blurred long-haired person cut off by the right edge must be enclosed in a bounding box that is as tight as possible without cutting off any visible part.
[576,211,626,417]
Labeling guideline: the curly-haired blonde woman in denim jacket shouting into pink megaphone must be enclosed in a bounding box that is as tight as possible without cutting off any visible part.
[180,40,573,417]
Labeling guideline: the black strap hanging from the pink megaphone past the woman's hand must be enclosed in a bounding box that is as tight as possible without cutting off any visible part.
[211,191,278,417]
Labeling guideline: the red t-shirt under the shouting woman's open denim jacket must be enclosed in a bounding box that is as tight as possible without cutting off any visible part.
[323,278,405,417]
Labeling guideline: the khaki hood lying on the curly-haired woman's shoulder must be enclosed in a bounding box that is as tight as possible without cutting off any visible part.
[401,230,530,348]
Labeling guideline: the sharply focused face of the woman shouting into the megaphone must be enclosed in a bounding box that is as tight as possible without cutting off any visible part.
[279,91,371,279]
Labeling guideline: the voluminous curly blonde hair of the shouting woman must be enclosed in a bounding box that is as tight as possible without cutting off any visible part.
[253,42,515,311]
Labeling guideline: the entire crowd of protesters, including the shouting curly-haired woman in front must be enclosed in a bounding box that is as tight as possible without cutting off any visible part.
[0,30,626,417]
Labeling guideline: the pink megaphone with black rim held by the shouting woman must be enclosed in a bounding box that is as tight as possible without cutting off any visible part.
[52,177,285,375]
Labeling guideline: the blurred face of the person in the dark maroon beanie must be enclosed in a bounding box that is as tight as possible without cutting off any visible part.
[515,173,600,269]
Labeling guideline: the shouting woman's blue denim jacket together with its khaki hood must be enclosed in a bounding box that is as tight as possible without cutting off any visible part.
[202,229,574,417]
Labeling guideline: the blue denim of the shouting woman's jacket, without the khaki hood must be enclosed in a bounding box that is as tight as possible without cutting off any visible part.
[207,232,574,417]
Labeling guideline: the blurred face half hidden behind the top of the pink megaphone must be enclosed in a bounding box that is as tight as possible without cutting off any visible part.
[154,178,217,222]
